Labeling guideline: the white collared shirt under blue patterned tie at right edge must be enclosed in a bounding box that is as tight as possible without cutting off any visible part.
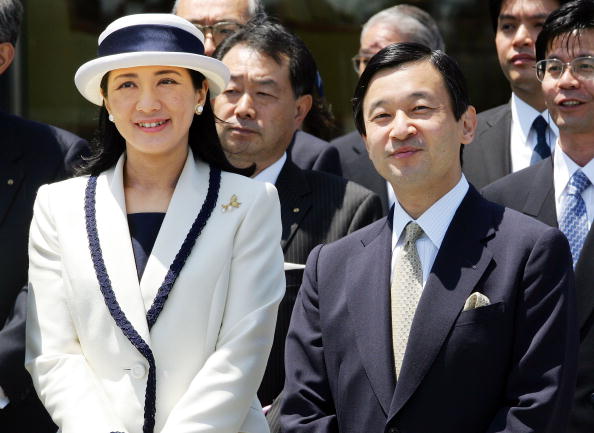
[553,146,594,230]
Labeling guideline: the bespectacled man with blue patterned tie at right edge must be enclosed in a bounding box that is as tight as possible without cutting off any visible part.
[484,0,594,433]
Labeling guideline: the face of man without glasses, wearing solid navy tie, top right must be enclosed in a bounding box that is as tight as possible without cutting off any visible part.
[495,0,559,95]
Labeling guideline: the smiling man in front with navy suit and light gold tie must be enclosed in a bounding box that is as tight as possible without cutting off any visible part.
[281,43,577,433]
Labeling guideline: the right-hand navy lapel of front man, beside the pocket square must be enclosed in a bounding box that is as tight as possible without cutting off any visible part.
[389,186,494,419]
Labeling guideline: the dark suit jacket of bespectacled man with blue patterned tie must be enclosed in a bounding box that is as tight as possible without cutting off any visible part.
[483,157,594,433]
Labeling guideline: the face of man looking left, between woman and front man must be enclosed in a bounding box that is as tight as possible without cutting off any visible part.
[213,44,311,174]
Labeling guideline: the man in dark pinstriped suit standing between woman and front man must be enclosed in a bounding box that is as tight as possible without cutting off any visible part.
[213,22,381,405]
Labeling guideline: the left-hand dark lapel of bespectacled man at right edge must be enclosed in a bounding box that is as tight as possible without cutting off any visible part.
[522,157,558,227]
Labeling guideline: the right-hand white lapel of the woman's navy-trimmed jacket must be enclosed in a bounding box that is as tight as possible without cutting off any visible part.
[140,151,208,313]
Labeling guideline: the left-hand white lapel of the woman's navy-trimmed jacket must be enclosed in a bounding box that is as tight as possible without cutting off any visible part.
[96,154,150,345]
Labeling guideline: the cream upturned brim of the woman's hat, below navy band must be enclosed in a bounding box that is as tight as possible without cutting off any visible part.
[74,51,229,106]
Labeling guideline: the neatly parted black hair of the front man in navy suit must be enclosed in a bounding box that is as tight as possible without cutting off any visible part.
[353,42,470,135]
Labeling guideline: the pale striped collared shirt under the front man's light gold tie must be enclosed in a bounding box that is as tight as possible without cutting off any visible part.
[391,175,468,287]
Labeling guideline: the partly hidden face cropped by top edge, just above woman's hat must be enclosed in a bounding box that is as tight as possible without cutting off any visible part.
[176,0,250,56]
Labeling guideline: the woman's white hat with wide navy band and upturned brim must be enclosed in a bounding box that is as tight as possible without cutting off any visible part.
[74,14,229,105]
